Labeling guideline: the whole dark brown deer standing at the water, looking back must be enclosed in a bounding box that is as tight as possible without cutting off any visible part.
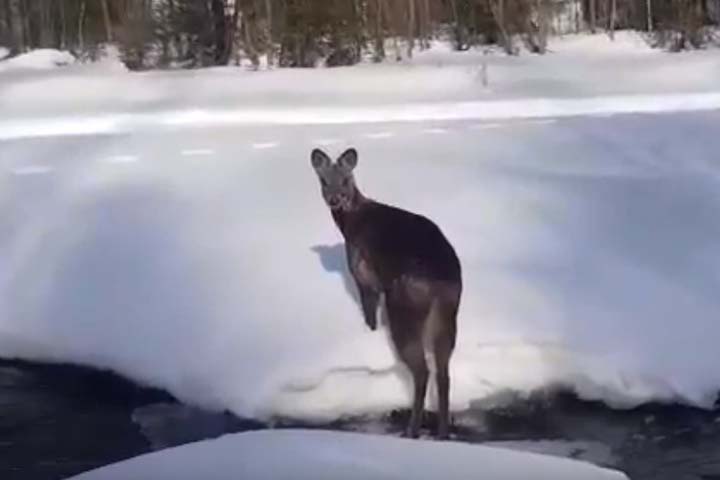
[311,148,462,439]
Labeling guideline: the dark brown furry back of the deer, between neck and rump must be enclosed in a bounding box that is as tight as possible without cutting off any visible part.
[345,201,461,285]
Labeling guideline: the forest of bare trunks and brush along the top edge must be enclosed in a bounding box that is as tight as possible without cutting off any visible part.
[0,0,720,70]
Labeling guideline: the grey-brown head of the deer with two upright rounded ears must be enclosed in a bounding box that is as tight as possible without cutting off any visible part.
[310,148,359,210]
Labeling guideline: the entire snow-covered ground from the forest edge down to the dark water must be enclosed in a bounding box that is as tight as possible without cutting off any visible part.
[0,35,720,428]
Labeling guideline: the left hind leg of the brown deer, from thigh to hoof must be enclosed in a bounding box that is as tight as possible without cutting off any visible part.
[385,284,429,438]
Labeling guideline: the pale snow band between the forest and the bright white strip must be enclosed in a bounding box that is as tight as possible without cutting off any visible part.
[0,34,720,118]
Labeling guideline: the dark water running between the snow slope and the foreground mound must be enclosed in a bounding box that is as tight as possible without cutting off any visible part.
[0,361,720,480]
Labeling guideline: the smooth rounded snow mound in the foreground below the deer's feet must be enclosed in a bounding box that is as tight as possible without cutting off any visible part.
[69,430,627,480]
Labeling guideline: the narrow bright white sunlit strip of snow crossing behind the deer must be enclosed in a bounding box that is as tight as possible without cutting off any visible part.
[0,92,720,140]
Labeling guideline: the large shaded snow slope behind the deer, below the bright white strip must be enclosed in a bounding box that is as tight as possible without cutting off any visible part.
[0,112,720,420]
